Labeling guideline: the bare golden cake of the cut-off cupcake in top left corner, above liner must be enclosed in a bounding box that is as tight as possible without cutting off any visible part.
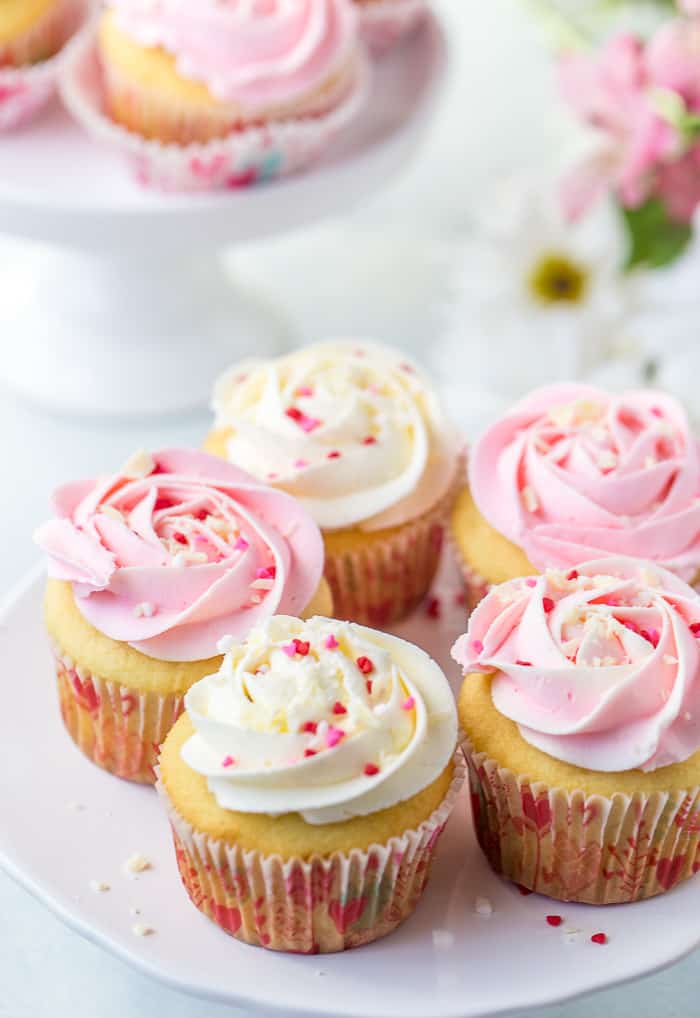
[0,0,84,67]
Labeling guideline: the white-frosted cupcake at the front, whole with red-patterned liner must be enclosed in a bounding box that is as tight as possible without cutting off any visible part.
[159,616,464,954]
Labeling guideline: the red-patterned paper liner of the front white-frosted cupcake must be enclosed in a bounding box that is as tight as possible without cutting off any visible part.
[158,754,465,954]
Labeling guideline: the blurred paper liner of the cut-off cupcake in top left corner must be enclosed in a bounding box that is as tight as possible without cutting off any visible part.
[0,0,91,131]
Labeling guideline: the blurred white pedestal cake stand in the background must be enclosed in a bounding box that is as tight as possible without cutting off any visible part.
[0,16,447,415]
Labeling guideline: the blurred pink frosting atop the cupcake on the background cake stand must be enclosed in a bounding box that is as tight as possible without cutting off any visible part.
[109,0,357,111]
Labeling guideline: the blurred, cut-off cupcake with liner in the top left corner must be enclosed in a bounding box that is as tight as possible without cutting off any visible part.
[0,0,86,130]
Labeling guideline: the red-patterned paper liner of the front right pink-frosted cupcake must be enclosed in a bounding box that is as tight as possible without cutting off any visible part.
[463,740,700,905]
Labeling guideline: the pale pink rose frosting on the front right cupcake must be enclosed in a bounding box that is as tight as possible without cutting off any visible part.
[452,558,700,771]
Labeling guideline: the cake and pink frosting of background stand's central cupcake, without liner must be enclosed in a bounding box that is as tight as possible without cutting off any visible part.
[98,0,358,145]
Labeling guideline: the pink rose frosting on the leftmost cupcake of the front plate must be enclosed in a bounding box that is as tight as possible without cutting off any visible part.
[36,449,324,661]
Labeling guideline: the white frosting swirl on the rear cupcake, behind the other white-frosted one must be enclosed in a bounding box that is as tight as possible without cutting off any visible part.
[214,340,460,530]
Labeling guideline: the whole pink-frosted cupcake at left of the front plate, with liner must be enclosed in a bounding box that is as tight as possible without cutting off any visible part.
[36,449,331,783]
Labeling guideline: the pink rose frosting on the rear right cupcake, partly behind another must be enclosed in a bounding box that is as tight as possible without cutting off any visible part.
[469,385,700,580]
